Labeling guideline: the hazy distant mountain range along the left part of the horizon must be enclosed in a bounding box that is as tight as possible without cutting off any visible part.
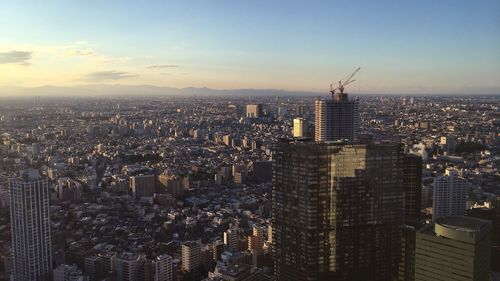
[0,84,322,97]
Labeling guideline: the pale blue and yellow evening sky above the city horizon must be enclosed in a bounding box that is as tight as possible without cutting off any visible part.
[0,0,500,94]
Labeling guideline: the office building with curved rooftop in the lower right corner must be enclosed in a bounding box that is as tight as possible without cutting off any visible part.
[415,216,491,281]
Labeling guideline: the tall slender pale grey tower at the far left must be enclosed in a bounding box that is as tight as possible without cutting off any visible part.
[9,169,52,281]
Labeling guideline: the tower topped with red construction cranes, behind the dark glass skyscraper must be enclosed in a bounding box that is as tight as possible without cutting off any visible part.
[315,93,359,142]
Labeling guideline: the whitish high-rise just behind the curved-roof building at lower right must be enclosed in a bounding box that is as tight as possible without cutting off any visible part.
[432,169,467,221]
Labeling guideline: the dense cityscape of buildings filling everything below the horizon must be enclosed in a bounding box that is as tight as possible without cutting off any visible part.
[0,91,500,281]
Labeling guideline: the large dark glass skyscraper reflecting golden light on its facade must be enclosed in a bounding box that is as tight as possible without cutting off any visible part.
[272,140,404,281]
